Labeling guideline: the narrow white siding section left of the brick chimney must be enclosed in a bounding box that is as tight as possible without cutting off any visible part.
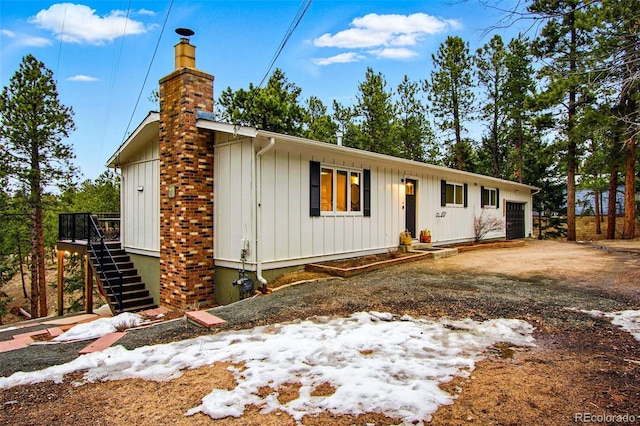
[120,140,160,256]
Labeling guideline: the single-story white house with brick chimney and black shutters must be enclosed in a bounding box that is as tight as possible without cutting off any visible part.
[108,32,537,308]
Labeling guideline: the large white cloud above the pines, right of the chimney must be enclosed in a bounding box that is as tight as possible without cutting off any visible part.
[313,13,459,49]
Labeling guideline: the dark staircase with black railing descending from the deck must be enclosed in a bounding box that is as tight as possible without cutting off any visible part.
[89,241,157,314]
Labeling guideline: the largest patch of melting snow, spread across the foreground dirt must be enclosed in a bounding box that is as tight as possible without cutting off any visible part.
[0,312,534,424]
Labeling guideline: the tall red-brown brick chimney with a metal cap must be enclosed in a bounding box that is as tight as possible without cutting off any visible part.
[159,29,215,309]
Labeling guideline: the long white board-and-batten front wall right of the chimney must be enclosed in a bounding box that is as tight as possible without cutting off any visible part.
[214,138,531,269]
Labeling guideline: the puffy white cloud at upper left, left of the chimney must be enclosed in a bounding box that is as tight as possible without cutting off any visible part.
[29,3,148,45]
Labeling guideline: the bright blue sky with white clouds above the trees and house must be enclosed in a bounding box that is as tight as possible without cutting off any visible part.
[0,0,518,179]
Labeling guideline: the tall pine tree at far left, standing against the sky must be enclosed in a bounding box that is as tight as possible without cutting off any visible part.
[0,55,75,317]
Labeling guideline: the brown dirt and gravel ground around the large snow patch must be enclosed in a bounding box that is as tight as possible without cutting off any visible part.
[0,240,640,425]
